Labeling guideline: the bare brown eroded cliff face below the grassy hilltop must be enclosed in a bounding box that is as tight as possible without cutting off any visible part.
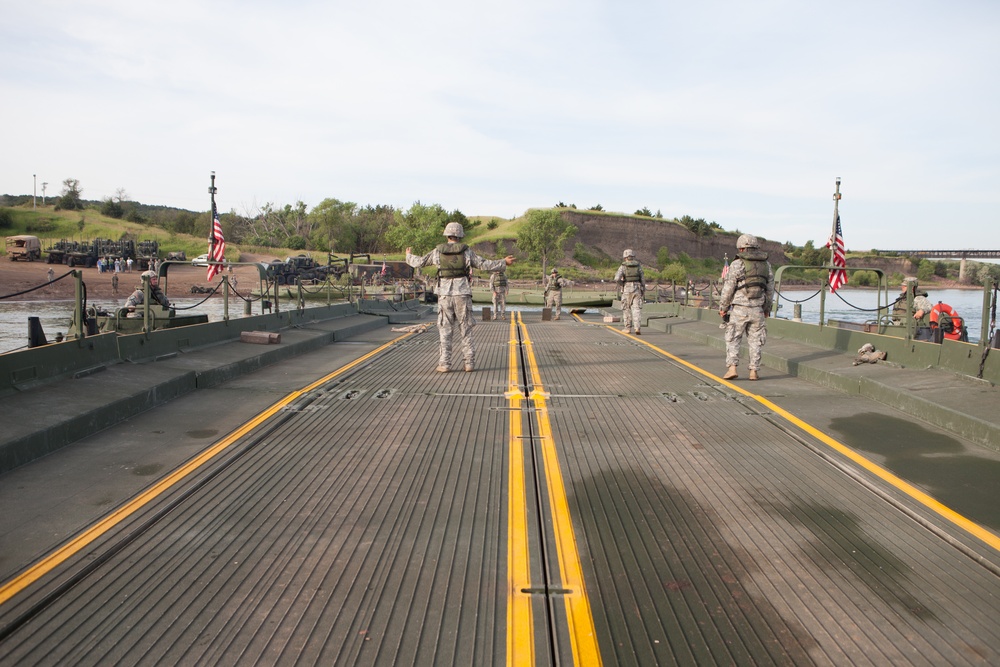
[562,211,785,266]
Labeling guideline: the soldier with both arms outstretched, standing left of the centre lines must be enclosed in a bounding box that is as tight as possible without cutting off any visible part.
[406,222,514,373]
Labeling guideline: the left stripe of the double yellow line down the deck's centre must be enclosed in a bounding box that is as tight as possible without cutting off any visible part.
[507,313,535,665]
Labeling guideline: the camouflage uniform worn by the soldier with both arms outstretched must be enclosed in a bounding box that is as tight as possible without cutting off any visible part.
[406,231,507,372]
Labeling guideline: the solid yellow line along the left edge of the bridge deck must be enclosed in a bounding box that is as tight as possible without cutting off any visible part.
[0,333,414,605]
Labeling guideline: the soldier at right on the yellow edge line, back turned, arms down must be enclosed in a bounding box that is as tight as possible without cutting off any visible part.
[719,234,774,380]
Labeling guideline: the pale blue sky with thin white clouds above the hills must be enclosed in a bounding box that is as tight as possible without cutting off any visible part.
[0,0,1000,250]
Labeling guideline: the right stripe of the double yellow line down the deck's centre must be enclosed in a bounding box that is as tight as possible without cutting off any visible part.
[521,323,601,665]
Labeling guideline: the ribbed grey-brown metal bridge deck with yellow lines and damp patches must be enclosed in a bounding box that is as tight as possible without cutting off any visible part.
[0,313,1000,665]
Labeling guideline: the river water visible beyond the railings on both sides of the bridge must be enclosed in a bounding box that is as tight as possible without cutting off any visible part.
[0,287,983,353]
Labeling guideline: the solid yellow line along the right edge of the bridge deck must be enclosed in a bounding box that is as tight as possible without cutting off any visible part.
[608,327,1000,551]
